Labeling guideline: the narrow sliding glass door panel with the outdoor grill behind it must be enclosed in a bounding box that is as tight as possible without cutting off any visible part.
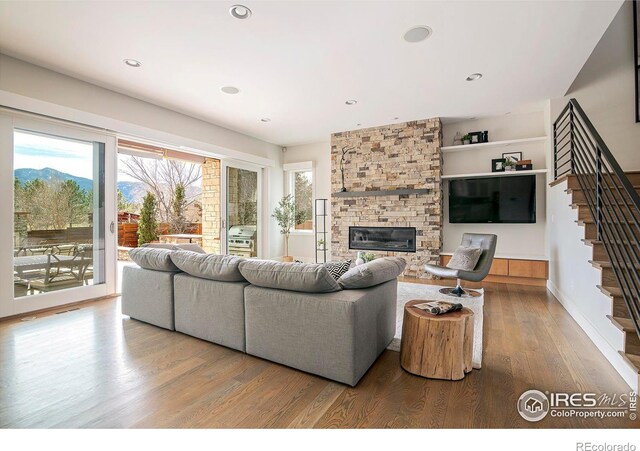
[221,164,262,258]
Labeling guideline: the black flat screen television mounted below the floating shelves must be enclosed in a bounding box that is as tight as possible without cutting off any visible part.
[449,175,536,224]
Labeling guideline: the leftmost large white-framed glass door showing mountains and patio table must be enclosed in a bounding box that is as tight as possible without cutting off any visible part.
[0,115,116,316]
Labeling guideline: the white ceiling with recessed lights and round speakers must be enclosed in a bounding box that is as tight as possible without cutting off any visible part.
[0,0,622,145]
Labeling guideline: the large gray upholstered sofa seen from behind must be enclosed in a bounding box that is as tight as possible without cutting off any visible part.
[122,248,405,386]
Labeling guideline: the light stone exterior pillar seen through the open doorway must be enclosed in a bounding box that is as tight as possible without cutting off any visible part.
[202,158,221,254]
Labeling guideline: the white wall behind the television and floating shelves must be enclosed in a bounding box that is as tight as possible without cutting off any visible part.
[442,111,547,259]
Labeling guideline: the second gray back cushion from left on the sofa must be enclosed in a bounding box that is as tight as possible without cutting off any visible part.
[171,251,245,282]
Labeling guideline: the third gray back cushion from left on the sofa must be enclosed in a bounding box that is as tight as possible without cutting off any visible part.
[240,260,341,293]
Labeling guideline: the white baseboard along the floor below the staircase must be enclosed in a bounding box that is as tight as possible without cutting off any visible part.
[547,280,639,393]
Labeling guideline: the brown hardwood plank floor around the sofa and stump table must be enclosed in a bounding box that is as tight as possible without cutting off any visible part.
[0,284,638,428]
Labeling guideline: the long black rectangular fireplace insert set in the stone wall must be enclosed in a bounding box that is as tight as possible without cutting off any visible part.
[349,226,416,252]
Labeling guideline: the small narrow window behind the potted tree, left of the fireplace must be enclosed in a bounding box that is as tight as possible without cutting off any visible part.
[285,162,313,232]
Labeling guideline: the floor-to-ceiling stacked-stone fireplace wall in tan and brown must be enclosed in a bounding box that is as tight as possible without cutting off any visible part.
[331,118,442,278]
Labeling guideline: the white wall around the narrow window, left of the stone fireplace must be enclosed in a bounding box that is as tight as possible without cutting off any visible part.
[283,141,331,262]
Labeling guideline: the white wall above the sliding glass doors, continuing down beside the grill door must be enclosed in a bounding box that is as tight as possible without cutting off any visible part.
[0,54,283,257]
